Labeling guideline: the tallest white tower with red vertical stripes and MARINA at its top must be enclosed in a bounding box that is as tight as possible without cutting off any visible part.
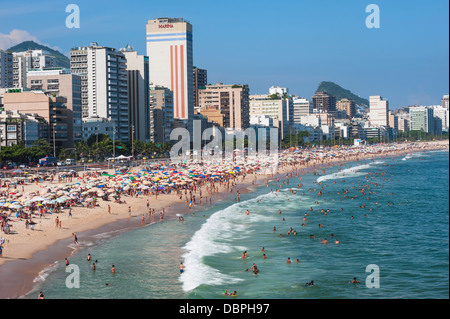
[147,18,194,128]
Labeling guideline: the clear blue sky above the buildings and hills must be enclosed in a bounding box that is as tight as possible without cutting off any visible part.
[0,0,449,108]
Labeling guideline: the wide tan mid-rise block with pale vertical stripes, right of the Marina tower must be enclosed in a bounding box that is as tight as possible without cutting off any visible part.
[198,83,250,130]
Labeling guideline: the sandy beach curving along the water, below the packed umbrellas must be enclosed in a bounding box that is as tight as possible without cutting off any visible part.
[0,140,449,299]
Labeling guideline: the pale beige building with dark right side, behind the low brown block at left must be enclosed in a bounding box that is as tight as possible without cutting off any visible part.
[27,69,83,145]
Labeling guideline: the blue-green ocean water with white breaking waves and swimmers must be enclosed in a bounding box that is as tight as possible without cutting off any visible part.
[25,151,449,299]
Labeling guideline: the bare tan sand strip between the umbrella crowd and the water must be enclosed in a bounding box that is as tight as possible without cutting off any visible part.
[0,140,449,299]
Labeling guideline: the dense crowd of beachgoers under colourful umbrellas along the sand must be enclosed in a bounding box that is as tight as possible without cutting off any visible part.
[0,143,448,298]
